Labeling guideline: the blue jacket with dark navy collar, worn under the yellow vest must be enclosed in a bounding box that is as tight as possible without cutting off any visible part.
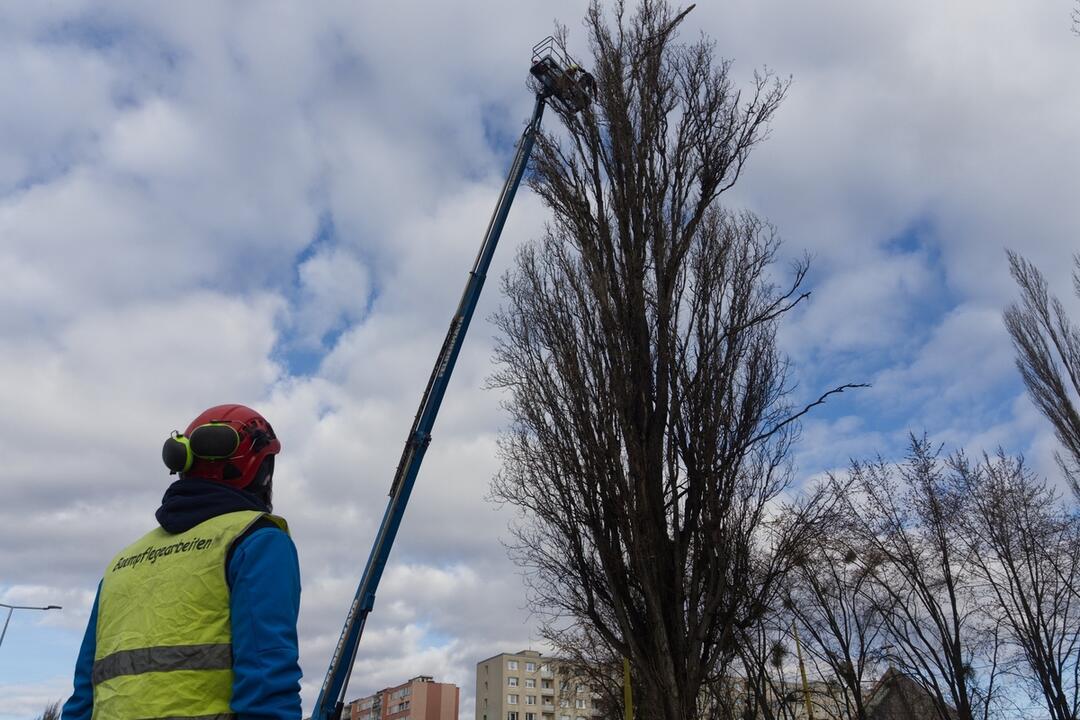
[60,478,301,720]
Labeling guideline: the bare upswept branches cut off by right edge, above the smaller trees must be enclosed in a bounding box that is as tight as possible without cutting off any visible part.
[1004,252,1080,498]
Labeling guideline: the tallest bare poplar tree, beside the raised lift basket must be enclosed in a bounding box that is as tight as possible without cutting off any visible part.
[491,0,859,720]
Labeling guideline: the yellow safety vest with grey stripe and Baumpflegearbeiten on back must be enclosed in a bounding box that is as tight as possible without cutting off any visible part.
[92,511,288,720]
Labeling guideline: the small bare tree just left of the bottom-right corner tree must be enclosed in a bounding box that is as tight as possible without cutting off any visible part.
[843,437,1000,720]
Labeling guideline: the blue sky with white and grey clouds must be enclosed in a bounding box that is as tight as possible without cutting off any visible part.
[0,0,1080,720]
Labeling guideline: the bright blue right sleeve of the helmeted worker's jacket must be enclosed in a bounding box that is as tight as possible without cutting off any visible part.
[223,528,301,720]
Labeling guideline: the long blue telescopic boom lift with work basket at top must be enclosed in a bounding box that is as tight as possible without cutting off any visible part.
[311,38,595,720]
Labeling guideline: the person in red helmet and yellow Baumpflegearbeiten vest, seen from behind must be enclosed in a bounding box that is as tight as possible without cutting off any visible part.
[62,405,301,720]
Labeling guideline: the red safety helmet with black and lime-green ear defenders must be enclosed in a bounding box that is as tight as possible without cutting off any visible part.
[162,405,281,488]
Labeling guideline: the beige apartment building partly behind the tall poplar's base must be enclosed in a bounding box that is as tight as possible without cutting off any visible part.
[475,650,597,720]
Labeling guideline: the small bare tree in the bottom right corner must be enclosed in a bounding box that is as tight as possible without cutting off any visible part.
[951,452,1080,720]
